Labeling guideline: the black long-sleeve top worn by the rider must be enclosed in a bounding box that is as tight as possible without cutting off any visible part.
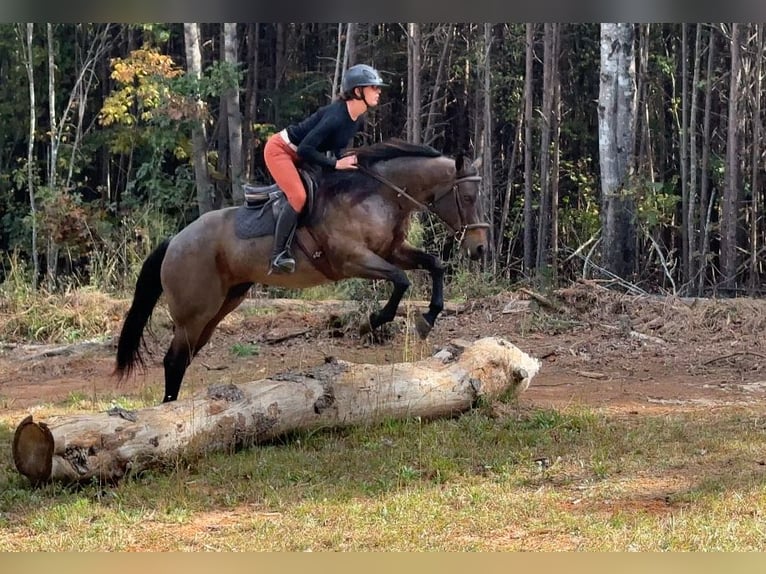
[287,100,364,169]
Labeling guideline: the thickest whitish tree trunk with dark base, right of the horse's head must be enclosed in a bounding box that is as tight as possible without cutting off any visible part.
[598,24,636,278]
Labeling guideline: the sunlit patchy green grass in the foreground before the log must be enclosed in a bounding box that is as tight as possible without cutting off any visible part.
[0,404,766,551]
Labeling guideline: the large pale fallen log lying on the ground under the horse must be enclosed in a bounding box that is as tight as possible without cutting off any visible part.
[13,337,540,484]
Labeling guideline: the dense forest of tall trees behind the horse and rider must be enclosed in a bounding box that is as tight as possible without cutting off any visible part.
[0,23,766,297]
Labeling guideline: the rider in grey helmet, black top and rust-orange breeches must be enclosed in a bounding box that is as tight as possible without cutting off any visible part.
[263,64,385,273]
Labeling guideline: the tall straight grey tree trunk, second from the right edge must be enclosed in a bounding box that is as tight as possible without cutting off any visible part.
[721,22,740,295]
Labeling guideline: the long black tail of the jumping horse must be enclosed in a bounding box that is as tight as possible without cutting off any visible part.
[113,239,170,380]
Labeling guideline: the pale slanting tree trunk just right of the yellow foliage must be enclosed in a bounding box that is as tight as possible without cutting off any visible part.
[184,22,213,215]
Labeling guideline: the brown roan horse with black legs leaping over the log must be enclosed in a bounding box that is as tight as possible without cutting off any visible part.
[115,141,489,402]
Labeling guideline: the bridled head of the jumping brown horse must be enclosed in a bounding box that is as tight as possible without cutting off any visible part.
[430,155,489,259]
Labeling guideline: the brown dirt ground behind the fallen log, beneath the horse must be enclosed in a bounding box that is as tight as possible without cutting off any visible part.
[0,283,766,416]
